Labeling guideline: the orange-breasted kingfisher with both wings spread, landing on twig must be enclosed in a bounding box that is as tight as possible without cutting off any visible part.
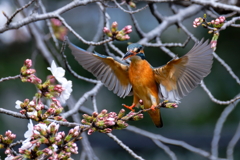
[68,40,213,128]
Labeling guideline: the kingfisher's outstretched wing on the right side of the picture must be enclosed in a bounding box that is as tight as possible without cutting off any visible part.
[153,40,213,102]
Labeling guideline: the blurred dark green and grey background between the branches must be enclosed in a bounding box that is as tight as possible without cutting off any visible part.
[0,0,240,160]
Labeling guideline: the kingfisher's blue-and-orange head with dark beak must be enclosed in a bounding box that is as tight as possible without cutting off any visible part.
[123,43,145,60]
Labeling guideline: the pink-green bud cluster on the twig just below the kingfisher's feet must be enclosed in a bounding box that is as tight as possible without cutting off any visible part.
[81,109,143,135]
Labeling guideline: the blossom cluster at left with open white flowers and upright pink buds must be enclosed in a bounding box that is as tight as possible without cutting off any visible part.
[15,59,72,121]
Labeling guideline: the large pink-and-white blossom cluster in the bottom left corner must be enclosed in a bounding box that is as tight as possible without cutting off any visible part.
[5,120,81,160]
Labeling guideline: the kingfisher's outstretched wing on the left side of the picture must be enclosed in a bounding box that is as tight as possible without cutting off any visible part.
[68,42,132,97]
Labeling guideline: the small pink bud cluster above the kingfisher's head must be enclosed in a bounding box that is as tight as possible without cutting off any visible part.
[103,22,132,41]
